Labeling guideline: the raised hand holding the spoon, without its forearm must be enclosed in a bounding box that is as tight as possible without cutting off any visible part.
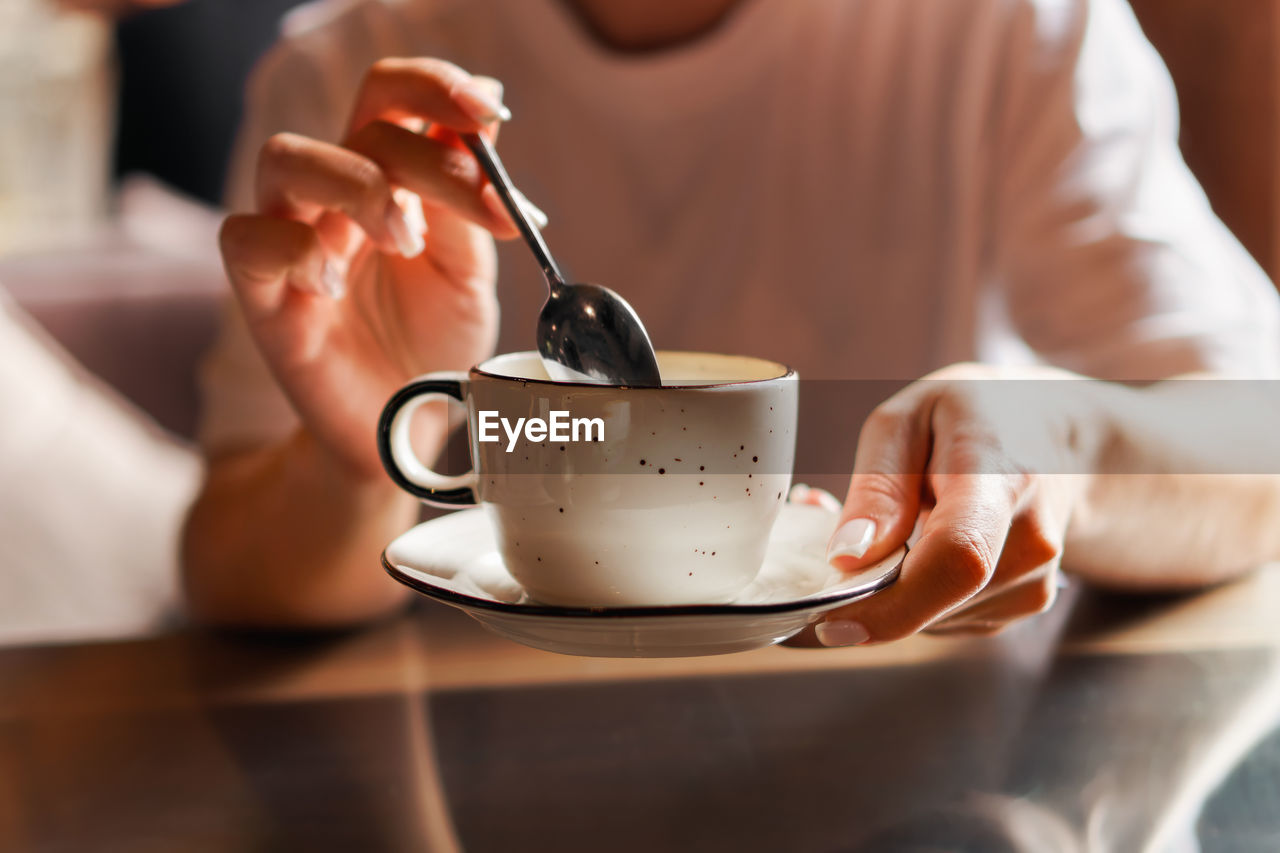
[221,59,540,479]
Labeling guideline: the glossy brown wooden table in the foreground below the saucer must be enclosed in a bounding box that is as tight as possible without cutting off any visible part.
[0,569,1280,852]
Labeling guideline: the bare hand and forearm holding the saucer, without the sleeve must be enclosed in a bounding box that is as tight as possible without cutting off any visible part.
[818,365,1280,646]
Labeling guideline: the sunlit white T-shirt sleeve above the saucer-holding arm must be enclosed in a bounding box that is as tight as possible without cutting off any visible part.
[993,0,1280,379]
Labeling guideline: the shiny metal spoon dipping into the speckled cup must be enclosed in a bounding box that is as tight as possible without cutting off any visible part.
[462,133,662,386]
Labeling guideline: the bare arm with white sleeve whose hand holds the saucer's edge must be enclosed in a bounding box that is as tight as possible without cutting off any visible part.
[817,0,1280,644]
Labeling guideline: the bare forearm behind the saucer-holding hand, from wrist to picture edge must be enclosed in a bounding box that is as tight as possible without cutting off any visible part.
[1064,380,1280,589]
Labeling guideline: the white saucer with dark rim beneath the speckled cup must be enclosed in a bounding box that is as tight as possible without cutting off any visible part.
[383,503,906,657]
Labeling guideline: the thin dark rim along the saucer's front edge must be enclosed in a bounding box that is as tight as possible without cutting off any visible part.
[383,545,910,619]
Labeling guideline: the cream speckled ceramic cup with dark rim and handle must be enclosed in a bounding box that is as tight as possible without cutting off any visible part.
[378,352,799,607]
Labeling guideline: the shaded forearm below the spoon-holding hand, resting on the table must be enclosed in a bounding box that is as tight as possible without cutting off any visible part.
[183,430,417,628]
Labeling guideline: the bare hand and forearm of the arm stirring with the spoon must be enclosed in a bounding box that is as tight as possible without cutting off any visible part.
[183,59,516,628]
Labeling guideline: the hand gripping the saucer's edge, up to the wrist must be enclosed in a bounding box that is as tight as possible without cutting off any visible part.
[815,365,1105,646]
